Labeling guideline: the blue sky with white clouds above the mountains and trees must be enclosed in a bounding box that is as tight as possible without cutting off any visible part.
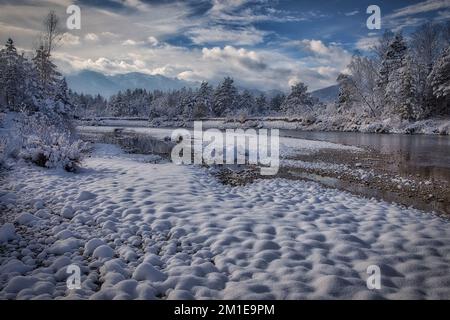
[0,0,450,90]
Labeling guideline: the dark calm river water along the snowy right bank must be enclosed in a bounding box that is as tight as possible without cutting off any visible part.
[280,130,450,182]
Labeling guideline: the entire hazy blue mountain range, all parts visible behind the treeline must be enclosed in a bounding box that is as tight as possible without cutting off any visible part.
[66,70,339,103]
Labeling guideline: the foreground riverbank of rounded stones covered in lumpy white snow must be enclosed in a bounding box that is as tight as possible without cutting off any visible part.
[0,142,450,299]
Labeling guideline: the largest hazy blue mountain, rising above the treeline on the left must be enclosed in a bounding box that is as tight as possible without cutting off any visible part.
[66,70,198,97]
